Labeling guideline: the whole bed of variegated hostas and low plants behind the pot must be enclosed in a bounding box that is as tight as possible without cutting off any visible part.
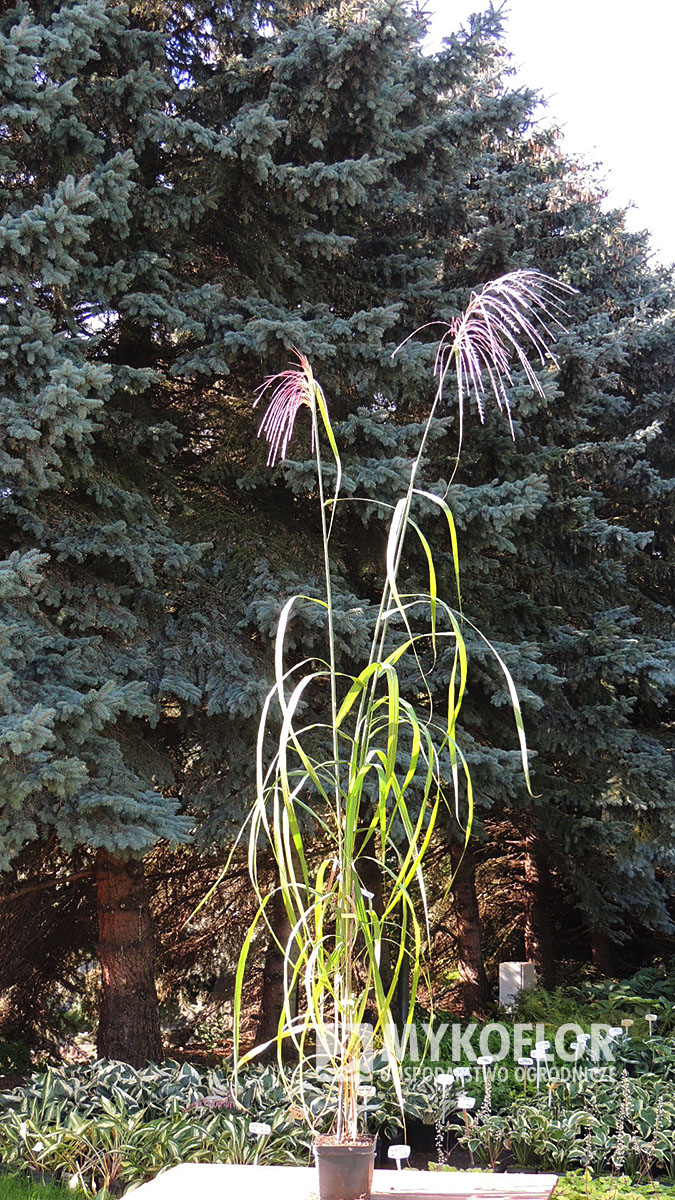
[0,1022,675,1200]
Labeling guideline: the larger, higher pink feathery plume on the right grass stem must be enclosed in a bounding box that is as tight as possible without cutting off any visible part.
[434,270,575,434]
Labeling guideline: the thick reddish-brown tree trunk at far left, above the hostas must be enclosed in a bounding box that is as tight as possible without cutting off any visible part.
[96,850,162,1067]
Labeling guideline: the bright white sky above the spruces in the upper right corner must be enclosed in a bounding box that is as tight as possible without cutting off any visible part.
[428,0,675,263]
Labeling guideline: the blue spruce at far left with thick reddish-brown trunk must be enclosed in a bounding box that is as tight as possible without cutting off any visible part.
[0,0,220,1062]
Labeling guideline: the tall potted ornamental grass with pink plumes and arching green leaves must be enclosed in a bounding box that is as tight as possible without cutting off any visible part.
[234,270,571,1200]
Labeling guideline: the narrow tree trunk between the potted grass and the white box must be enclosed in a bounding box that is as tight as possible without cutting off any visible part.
[450,840,490,1016]
